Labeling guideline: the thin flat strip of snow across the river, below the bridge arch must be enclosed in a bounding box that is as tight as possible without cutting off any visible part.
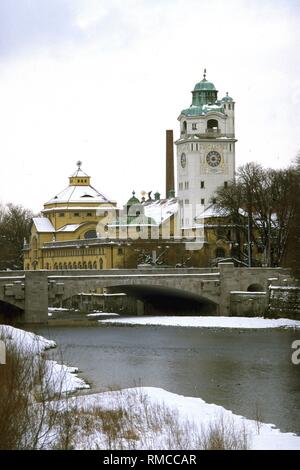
[99,317,300,329]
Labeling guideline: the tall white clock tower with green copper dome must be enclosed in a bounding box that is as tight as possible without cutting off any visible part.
[175,70,236,227]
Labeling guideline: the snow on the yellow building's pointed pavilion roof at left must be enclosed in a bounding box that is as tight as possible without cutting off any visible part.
[46,186,114,204]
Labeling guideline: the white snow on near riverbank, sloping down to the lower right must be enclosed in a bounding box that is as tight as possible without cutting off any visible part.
[62,387,300,450]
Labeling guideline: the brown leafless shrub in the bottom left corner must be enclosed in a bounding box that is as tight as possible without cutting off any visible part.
[0,337,78,450]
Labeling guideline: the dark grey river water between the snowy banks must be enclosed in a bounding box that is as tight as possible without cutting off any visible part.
[35,326,300,435]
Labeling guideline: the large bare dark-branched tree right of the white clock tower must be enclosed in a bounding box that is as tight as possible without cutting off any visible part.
[216,163,295,266]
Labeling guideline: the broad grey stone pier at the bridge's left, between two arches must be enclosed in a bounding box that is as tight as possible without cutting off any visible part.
[24,271,48,323]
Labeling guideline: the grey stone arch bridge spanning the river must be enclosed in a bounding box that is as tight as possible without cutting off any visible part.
[0,263,288,323]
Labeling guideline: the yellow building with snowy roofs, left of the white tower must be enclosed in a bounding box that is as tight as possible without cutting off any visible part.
[24,164,195,270]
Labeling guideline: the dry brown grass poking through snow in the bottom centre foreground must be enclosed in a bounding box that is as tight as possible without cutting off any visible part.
[54,389,249,450]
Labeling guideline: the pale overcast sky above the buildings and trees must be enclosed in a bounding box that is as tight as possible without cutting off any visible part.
[0,0,300,212]
